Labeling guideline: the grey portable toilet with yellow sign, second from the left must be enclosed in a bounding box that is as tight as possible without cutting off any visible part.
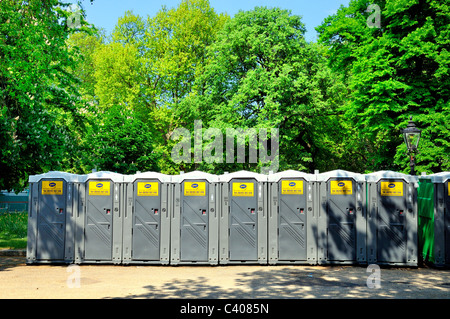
[75,172,124,264]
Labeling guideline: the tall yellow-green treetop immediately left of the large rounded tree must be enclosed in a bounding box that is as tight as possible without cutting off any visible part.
[145,0,228,106]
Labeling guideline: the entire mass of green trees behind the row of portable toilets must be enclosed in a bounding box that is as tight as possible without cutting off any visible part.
[0,0,450,190]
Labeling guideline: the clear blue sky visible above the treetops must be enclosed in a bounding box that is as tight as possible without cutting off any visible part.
[66,0,349,41]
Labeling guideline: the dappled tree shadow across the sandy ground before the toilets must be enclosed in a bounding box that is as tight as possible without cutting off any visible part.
[121,267,450,299]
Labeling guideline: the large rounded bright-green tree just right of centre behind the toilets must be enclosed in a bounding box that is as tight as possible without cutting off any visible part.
[179,7,344,171]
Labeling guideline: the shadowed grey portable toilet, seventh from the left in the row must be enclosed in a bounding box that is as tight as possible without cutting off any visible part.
[316,170,367,264]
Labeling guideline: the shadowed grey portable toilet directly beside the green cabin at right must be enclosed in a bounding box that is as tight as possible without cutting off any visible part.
[366,171,419,266]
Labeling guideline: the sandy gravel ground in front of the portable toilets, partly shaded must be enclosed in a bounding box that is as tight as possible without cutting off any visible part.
[0,256,450,299]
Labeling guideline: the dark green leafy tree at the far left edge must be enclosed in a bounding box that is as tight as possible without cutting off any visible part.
[0,0,90,191]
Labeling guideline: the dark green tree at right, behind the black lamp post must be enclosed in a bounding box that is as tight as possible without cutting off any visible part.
[317,0,450,173]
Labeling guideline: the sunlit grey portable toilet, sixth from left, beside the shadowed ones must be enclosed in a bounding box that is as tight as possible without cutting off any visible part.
[267,170,318,265]
